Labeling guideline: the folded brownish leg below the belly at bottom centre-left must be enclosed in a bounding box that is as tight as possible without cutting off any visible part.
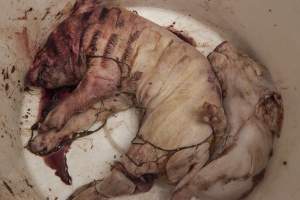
[68,144,168,200]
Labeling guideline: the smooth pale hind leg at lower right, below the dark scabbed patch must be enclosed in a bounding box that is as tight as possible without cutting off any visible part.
[172,119,272,200]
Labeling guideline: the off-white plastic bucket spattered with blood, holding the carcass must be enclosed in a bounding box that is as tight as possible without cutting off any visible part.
[0,0,300,200]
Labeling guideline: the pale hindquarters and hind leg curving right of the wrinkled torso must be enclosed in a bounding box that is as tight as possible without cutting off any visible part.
[172,42,283,200]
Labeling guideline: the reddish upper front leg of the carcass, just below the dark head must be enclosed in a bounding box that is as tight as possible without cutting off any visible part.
[39,58,120,132]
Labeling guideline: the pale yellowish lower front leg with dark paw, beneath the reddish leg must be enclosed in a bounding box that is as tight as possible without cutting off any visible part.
[27,92,133,155]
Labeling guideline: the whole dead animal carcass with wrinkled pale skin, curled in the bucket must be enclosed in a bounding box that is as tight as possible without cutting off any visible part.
[28,0,283,200]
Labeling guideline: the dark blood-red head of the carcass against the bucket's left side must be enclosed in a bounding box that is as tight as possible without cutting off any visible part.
[26,29,81,89]
